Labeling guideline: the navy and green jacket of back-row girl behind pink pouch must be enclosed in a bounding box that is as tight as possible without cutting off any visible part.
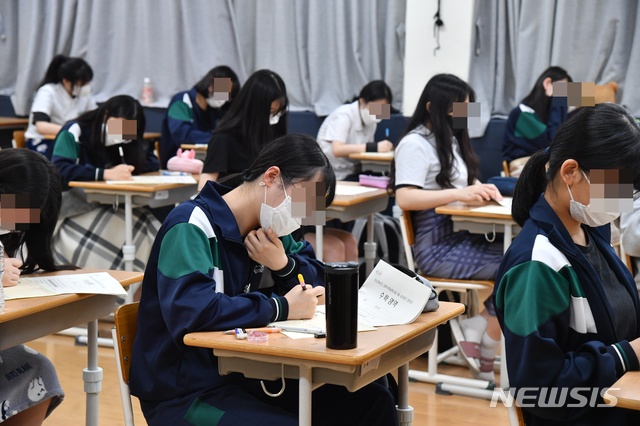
[160,89,229,169]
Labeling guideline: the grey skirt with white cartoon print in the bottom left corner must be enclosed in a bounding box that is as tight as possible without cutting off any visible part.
[0,345,64,423]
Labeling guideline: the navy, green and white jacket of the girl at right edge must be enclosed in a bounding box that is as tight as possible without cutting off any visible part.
[493,195,640,425]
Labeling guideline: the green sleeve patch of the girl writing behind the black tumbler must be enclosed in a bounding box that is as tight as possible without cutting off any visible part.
[158,223,214,279]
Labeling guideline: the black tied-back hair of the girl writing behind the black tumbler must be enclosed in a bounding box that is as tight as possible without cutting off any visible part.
[220,134,336,207]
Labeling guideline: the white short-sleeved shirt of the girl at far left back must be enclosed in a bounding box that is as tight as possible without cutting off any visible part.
[24,83,98,140]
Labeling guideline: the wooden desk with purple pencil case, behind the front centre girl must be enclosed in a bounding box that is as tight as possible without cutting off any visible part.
[316,181,389,274]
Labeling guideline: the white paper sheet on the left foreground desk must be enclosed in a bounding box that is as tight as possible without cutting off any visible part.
[4,272,127,300]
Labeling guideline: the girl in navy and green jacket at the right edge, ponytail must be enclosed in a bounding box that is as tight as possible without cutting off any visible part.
[493,104,640,425]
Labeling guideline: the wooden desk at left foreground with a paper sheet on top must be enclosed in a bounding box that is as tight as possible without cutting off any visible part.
[0,269,143,426]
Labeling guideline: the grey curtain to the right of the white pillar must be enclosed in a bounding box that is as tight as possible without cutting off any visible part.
[469,0,640,134]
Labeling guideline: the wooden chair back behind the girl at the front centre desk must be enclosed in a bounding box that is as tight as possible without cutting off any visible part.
[111,302,140,426]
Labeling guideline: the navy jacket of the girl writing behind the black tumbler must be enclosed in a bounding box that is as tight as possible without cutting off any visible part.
[130,182,324,406]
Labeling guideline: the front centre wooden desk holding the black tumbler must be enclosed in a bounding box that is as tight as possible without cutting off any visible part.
[184,302,464,425]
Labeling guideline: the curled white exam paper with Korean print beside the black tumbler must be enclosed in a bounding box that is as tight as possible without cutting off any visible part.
[358,260,431,327]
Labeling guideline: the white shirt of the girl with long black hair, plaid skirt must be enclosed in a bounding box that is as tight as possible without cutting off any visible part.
[395,125,469,190]
